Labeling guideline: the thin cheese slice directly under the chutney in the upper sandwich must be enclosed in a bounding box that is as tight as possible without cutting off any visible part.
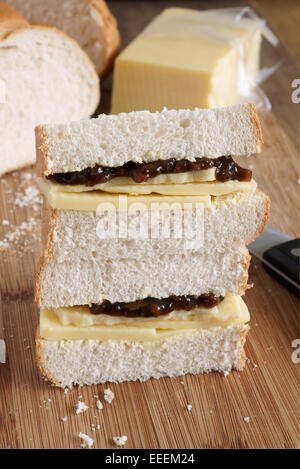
[52,168,216,192]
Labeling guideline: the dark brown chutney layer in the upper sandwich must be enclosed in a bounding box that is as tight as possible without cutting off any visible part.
[46,156,252,186]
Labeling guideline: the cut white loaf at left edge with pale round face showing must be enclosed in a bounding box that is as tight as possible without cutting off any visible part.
[0,2,100,175]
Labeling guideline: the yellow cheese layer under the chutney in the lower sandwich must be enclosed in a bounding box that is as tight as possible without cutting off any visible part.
[40,294,250,341]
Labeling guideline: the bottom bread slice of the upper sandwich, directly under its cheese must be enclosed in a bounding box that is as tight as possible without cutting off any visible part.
[43,190,269,264]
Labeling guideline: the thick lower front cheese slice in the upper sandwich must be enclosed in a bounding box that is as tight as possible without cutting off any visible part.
[39,179,211,211]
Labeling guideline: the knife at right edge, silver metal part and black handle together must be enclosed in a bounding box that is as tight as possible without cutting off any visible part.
[248,225,300,293]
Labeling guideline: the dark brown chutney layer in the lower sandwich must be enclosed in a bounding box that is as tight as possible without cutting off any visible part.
[89,293,224,318]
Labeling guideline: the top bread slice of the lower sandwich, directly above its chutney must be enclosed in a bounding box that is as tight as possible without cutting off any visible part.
[35,248,250,308]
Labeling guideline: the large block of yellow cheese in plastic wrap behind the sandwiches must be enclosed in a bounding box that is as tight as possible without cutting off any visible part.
[111,8,261,114]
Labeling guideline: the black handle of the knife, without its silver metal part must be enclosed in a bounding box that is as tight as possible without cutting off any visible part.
[263,238,300,295]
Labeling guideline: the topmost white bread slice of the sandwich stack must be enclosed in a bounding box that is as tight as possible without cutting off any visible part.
[36,104,262,175]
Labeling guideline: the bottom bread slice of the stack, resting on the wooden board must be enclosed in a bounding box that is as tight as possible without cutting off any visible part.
[36,324,249,387]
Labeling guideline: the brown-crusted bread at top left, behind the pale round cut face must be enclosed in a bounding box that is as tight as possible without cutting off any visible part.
[6,0,120,76]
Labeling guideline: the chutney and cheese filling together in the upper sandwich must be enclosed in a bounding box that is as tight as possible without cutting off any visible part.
[41,156,256,205]
